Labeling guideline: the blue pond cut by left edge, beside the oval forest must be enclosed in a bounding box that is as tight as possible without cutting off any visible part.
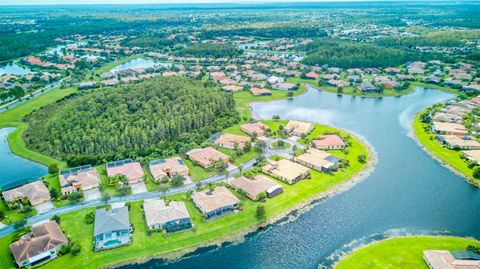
[0,128,47,190]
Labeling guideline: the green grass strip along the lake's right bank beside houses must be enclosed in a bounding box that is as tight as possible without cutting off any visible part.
[413,112,480,186]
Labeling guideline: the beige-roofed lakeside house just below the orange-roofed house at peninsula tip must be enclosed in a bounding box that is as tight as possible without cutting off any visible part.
[293,148,341,172]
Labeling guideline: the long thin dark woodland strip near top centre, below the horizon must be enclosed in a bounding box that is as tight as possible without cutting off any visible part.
[200,24,327,38]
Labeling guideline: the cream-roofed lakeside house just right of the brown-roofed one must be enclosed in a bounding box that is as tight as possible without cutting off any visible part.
[262,159,310,184]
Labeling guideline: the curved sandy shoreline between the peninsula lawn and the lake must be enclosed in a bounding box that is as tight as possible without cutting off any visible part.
[105,134,378,268]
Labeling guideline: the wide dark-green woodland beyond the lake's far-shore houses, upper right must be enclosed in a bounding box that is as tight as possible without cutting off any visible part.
[303,38,446,68]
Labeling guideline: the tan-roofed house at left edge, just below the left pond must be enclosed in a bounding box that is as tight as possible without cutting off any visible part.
[2,180,51,206]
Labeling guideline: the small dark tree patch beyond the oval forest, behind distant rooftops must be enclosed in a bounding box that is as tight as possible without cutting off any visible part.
[175,44,243,58]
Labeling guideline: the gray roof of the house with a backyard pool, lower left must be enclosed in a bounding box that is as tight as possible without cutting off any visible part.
[93,206,130,236]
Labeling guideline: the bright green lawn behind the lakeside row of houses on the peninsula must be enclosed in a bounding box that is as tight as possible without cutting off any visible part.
[0,122,368,269]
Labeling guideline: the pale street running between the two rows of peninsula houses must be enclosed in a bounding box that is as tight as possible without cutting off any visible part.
[0,160,256,237]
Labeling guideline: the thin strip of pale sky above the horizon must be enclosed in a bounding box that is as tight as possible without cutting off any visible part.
[0,0,378,6]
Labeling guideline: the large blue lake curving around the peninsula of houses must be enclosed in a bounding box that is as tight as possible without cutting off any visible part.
[125,86,480,269]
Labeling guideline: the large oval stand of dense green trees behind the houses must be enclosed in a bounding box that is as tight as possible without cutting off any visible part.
[24,77,239,165]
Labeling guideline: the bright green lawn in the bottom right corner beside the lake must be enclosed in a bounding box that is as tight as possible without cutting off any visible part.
[335,236,480,269]
